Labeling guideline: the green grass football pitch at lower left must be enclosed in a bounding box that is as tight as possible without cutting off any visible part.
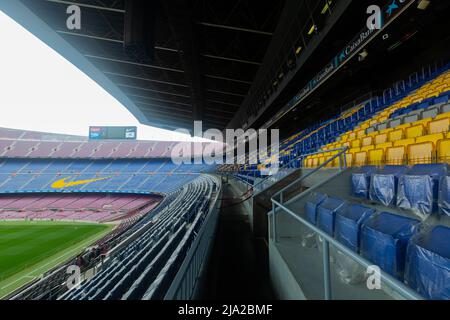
[0,221,113,298]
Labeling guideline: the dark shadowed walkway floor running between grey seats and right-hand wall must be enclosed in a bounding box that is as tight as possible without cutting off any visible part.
[201,184,275,300]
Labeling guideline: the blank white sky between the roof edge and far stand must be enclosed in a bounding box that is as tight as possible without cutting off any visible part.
[0,11,209,140]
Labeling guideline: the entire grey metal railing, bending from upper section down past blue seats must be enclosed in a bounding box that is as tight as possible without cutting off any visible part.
[269,148,423,300]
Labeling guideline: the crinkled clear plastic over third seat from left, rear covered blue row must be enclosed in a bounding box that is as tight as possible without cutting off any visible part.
[397,175,435,217]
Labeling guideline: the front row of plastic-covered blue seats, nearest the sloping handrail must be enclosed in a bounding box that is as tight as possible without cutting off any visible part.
[305,193,450,299]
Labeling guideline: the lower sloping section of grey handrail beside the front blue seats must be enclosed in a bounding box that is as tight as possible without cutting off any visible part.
[271,198,423,300]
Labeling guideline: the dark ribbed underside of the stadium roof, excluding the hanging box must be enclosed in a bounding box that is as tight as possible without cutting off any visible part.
[21,0,286,129]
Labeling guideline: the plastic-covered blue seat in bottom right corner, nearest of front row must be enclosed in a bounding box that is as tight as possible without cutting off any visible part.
[405,226,450,300]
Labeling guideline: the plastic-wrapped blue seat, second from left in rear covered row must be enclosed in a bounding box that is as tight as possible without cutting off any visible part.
[369,166,408,206]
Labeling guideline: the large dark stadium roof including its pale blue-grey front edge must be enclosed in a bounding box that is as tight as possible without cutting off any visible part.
[2,0,351,129]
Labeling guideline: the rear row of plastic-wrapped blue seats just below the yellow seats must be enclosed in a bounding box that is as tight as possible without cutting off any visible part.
[351,165,450,216]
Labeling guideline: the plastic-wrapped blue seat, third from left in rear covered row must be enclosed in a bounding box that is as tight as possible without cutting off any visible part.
[397,164,447,215]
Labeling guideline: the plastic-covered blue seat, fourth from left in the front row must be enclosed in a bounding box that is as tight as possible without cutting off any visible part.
[360,212,419,280]
